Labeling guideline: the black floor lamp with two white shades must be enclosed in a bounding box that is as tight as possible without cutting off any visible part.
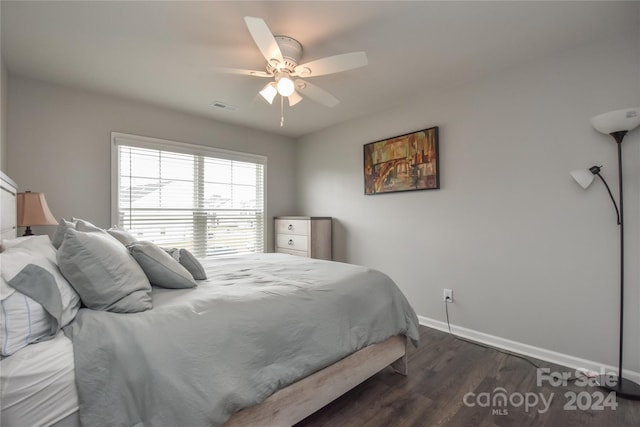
[571,108,640,400]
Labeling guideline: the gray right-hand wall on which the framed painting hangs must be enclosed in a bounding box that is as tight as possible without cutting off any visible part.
[298,33,640,372]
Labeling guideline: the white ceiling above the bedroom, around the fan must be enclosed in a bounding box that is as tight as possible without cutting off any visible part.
[1,0,640,137]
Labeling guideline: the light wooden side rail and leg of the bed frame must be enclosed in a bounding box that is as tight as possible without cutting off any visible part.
[225,335,407,427]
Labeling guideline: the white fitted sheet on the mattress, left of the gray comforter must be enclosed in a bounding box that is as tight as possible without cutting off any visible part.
[0,331,78,427]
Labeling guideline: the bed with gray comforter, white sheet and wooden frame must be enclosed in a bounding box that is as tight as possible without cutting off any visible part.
[0,172,418,426]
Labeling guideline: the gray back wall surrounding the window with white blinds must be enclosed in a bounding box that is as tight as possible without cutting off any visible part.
[7,76,295,251]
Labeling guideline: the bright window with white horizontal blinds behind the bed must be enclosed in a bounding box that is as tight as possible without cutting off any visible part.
[112,133,266,258]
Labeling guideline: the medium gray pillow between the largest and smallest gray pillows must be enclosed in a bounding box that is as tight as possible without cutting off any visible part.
[127,242,196,289]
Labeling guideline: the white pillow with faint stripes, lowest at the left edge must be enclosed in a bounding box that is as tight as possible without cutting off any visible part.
[0,290,51,356]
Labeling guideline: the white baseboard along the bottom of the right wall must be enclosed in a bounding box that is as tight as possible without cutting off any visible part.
[418,316,640,383]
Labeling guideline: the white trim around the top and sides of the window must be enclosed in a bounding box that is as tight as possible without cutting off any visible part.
[110,132,268,253]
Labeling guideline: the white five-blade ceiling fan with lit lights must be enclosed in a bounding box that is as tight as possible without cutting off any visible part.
[221,16,368,126]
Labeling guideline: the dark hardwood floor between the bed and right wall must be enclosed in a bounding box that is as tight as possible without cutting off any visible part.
[296,326,640,427]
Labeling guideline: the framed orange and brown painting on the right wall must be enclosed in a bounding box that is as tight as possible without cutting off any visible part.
[364,126,440,194]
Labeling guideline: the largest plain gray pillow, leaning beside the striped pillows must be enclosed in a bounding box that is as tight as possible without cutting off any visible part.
[57,228,152,313]
